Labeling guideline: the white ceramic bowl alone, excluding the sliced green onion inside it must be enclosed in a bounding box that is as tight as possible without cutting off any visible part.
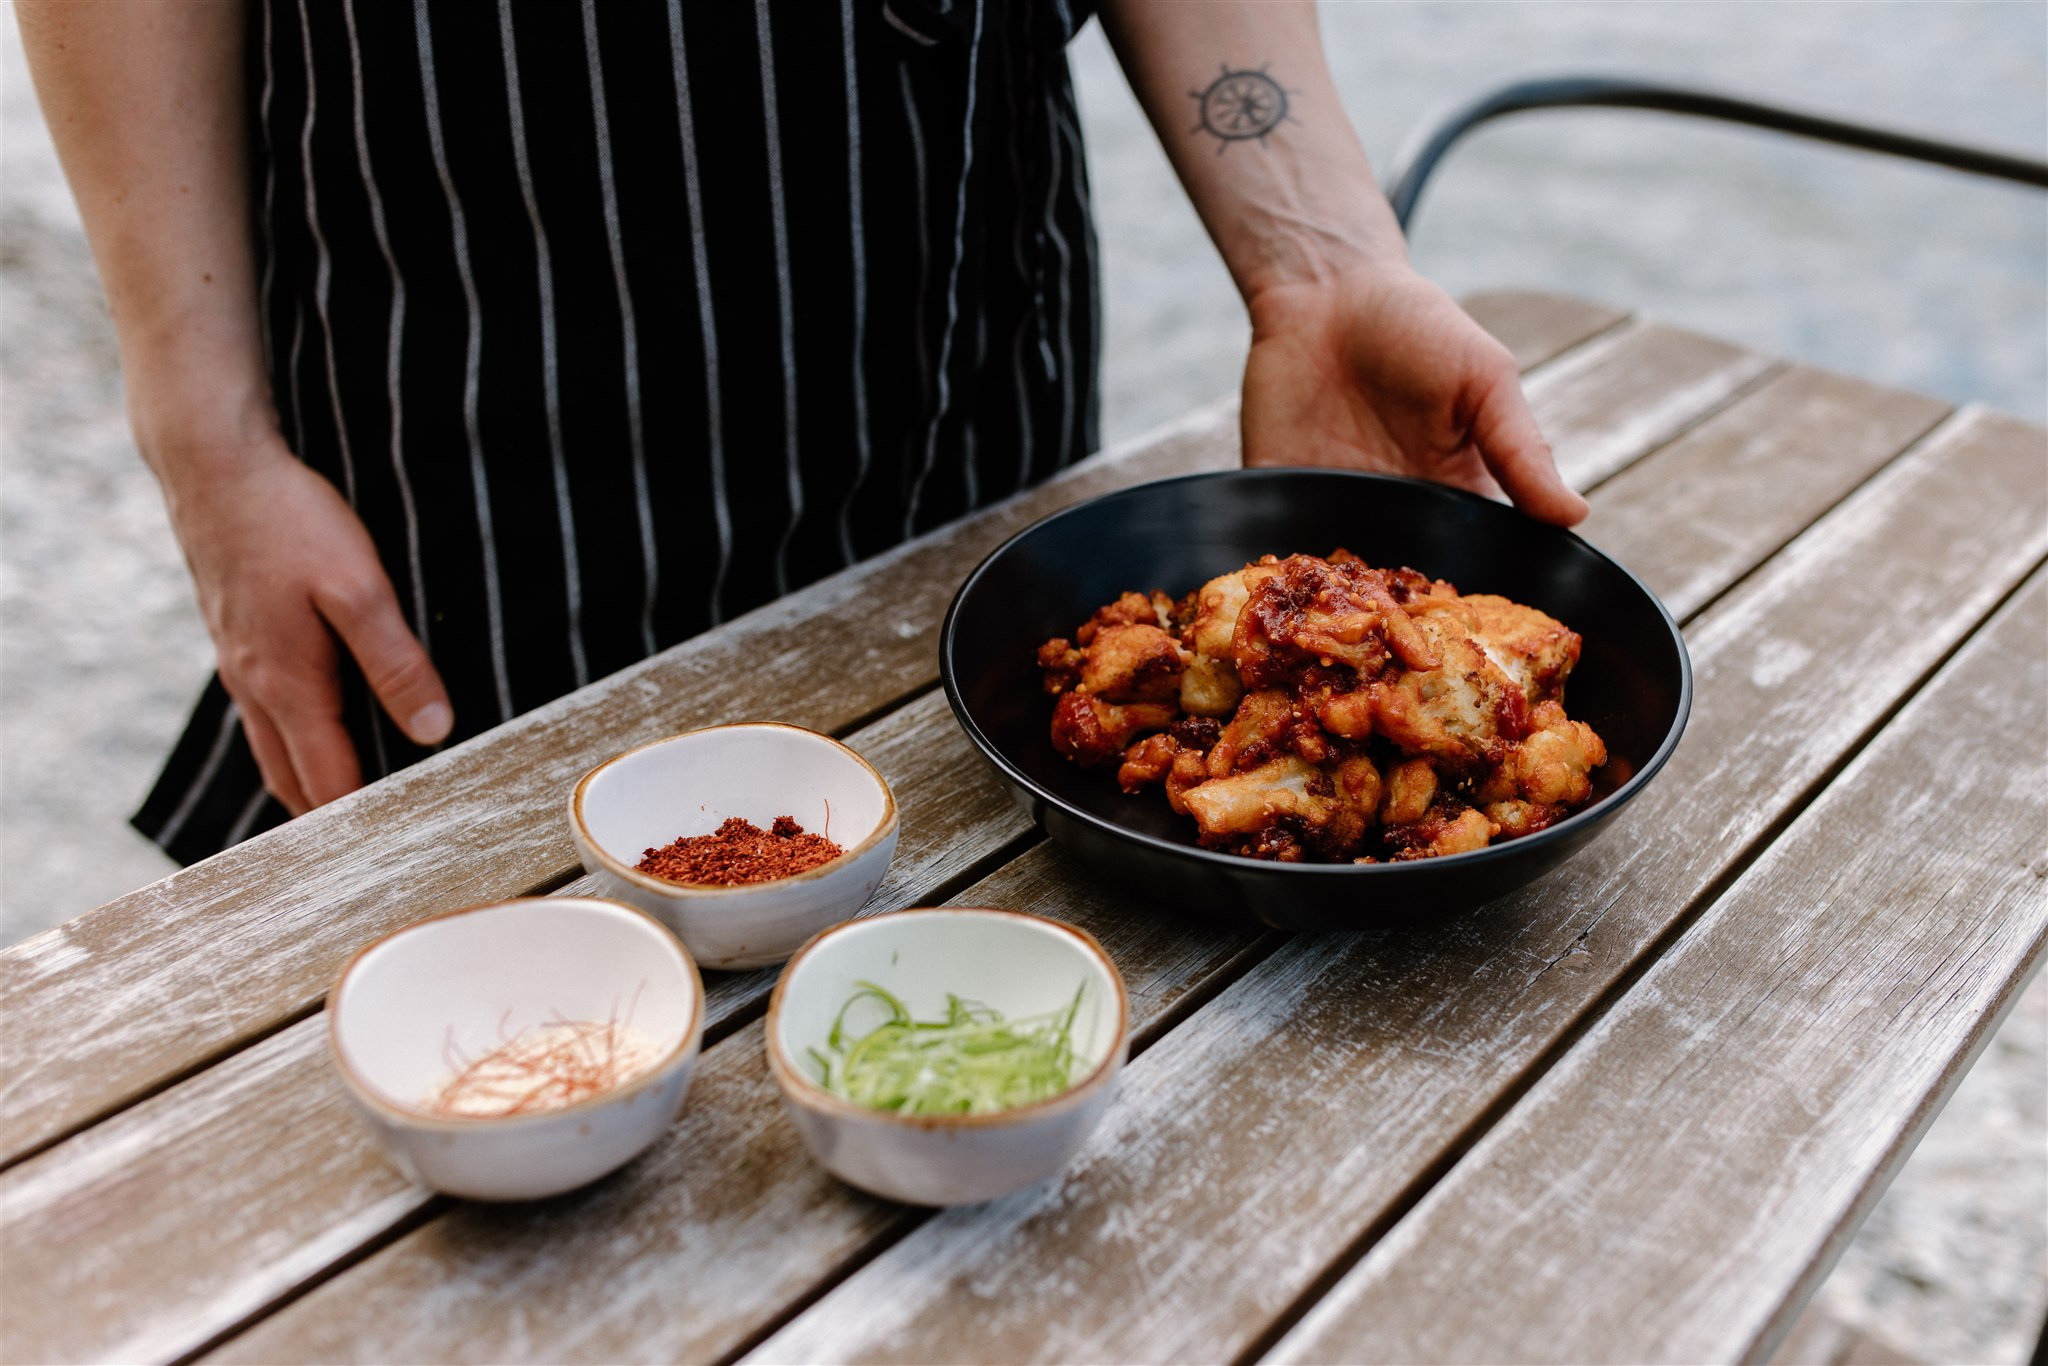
[768,907,1130,1204]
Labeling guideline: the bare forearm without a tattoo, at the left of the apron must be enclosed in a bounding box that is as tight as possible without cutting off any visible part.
[16,0,274,496]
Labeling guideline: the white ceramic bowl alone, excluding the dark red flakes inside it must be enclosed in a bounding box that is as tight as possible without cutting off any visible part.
[569,721,897,969]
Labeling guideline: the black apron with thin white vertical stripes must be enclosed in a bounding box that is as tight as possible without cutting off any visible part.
[135,0,1100,862]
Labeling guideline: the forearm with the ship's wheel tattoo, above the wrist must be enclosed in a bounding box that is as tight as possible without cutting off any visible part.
[1102,0,1407,299]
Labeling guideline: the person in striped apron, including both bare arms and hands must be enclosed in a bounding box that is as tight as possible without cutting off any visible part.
[16,0,1585,862]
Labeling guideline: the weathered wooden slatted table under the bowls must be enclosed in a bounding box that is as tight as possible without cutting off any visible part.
[0,293,2048,1362]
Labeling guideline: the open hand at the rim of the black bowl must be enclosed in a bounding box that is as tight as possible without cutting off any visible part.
[1241,266,1587,526]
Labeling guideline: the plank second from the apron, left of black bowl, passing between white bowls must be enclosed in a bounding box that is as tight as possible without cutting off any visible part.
[0,692,1030,1362]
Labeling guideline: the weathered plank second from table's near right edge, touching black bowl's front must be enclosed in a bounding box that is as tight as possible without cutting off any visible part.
[737,416,2048,1360]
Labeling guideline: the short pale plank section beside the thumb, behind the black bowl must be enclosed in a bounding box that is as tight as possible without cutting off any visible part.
[1522,322,1782,489]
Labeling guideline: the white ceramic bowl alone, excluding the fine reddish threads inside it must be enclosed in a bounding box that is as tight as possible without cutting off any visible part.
[328,897,705,1200]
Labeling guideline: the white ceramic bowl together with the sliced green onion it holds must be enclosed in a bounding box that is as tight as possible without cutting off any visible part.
[768,907,1130,1204]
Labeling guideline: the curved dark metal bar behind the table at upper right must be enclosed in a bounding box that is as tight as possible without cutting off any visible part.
[1386,76,2048,229]
